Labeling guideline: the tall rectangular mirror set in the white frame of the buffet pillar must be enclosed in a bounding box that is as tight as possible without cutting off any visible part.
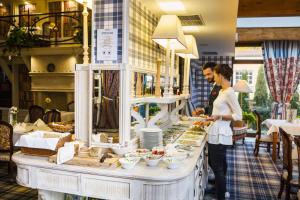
[92,70,120,143]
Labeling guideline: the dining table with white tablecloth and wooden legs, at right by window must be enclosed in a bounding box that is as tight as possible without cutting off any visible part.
[262,119,300,161]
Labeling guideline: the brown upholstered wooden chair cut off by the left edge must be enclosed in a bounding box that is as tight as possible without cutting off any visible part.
[0,121,13,176]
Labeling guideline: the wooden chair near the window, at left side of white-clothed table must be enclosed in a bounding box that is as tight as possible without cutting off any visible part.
[253,110,280,157]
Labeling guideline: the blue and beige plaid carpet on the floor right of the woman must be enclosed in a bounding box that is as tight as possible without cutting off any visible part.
[204,138,296,200]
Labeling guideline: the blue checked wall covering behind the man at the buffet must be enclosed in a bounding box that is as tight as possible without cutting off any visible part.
[189,56,232,113]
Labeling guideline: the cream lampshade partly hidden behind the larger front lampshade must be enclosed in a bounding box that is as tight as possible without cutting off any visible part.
[176,35,199,59]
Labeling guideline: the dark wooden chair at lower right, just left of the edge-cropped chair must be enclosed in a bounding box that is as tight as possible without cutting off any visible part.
[278,128,299,200]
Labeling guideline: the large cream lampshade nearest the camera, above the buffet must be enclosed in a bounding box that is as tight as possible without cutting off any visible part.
[152,15,186,50]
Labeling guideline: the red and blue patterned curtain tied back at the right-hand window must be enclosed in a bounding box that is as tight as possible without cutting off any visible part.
[264,41,300,119]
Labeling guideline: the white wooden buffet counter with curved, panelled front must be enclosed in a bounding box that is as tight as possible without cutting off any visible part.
[13,134,207,200]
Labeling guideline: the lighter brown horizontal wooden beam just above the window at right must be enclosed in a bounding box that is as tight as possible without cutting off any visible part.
[237,27,300,43]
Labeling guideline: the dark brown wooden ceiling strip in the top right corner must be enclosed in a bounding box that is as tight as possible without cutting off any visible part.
[238,0,300,17]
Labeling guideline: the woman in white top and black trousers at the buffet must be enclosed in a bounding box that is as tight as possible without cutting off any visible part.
[208,64,242,199]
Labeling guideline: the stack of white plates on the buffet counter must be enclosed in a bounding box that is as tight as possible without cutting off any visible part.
[140,128,163,149]
